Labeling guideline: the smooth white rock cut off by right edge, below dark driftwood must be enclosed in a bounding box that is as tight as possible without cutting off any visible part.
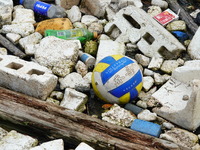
[188,27,200,59]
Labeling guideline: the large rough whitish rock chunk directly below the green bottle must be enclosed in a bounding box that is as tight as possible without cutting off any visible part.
[35,36,79,77]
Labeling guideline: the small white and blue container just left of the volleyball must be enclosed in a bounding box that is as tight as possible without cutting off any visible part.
[78,51,96,69]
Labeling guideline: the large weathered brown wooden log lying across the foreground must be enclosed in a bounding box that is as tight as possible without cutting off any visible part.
[0,87,185,150]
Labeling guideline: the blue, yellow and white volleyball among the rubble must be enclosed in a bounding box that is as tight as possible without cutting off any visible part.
[92,55,142,104]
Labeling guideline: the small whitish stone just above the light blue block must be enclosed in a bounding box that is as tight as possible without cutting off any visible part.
[137,109,157,121]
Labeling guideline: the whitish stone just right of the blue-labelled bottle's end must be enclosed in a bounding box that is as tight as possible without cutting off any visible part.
[66,6,81,23]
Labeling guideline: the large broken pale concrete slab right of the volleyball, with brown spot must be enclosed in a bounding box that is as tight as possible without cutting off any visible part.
[152,78,200,131]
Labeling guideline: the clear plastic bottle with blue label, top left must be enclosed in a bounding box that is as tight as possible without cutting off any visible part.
[19,0,66,18]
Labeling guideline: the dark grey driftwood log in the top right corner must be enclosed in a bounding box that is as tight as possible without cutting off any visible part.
[166,0,198,35]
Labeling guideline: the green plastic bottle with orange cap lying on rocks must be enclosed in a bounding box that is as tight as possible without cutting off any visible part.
[45,28,97,43]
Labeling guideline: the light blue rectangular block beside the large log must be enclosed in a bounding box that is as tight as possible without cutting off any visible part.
[131,119,161,137]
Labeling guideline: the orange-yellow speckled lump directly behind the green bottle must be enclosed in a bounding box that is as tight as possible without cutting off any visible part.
[35,18,73,35]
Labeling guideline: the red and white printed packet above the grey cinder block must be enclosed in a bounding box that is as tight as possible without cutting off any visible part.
[153,9,179,26]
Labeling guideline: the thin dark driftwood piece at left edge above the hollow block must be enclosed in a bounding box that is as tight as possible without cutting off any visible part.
[0,34,26,58]
